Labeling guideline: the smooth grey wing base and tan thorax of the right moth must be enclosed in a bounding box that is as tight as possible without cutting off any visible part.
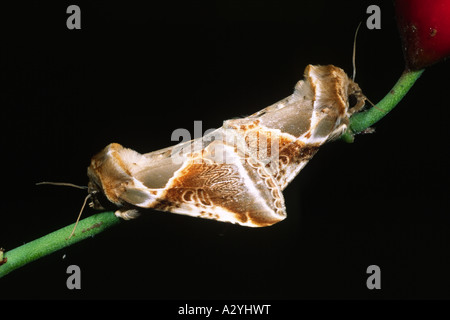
[248,65,351,143]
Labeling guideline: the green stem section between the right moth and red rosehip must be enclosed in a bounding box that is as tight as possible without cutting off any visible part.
[341,69,425,142]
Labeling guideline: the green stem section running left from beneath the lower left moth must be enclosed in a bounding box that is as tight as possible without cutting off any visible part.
[0,212,120,278]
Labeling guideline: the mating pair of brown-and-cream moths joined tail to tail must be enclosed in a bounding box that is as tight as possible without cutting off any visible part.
[87,65,366,227]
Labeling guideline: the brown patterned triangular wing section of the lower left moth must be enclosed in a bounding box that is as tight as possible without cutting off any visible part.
[128,132,286,227]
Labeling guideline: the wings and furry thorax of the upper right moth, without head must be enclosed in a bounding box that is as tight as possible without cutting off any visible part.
[224,65,356,190]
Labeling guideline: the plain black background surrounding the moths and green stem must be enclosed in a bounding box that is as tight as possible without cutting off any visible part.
[0,0,450,300]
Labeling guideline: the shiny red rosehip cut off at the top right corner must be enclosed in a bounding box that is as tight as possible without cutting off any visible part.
[395,0,450,70]
